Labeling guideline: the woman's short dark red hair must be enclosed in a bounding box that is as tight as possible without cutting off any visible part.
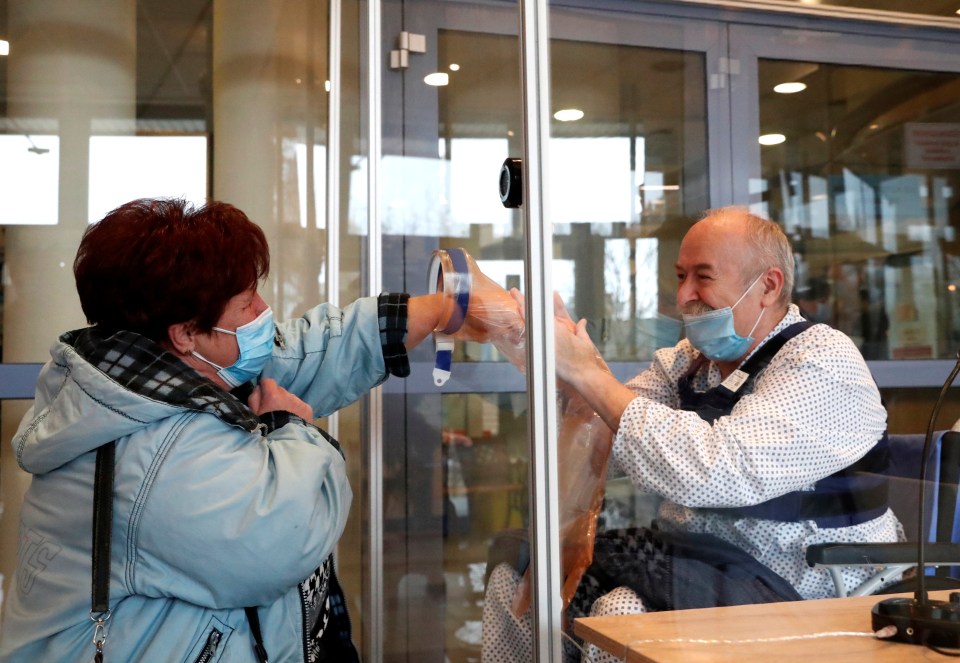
[73,198,270,342]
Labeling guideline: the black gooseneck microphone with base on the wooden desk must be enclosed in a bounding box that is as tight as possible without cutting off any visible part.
[871,354,960,651]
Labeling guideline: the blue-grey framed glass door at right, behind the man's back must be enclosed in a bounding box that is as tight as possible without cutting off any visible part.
[730,26,960,432]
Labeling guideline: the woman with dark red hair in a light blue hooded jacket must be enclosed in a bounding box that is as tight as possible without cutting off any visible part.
[0,200,520,663]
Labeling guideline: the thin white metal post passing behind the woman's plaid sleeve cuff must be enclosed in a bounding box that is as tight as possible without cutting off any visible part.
[364,0,384,663]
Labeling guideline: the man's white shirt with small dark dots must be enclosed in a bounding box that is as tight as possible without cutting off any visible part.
[613,304,903,598]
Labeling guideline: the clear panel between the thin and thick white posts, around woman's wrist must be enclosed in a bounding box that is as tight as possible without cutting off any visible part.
[376,10,527,663]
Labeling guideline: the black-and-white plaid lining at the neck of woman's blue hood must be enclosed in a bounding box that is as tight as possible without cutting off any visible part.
[60,326,261,432]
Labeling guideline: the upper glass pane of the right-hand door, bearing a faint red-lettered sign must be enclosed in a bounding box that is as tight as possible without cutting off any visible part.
[758,60,960,359]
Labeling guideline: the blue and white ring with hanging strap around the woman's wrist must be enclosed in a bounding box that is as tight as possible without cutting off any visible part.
[427,249,471,387]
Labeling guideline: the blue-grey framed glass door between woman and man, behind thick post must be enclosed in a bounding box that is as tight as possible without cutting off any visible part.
[374,2,729,663]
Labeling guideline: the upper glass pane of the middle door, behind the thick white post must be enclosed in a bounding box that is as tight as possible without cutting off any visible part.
[434,31,708,368]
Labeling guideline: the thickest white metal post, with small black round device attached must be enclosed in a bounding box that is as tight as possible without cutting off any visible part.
[520,0,563,663]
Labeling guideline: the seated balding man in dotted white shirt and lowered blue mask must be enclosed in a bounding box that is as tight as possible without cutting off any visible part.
[484,207,902,661]
